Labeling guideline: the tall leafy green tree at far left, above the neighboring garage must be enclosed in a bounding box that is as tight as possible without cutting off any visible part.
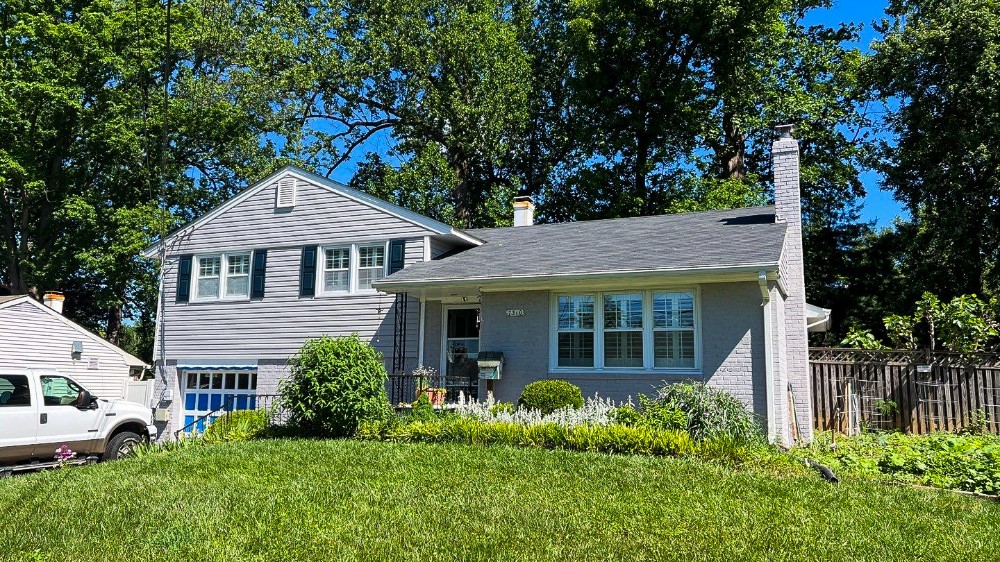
[0,0,294,354]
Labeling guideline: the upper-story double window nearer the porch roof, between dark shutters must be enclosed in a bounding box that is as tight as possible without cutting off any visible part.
[317,242,386,295]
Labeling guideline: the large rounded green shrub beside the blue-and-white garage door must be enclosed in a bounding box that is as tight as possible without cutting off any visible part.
[281,334,392,437]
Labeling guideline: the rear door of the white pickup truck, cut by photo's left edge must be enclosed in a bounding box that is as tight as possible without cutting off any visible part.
[0,374,41,465]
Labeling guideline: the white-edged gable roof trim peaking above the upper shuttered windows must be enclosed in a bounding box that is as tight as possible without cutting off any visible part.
[142,165,483,258]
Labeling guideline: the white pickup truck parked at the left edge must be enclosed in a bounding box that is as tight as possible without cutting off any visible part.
[0,369,156,471]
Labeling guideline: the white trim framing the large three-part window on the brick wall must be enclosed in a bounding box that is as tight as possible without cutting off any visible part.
[549,287,703,376]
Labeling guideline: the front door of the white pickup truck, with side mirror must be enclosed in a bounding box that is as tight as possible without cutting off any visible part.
[35,375,104,458]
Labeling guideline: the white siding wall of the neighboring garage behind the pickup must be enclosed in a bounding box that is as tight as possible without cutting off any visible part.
[0,302,129,400]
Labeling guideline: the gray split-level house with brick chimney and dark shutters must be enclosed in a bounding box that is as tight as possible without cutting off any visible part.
[147,127,829,442]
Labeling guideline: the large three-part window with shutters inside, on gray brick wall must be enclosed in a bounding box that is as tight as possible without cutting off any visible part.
[552,291,699,371]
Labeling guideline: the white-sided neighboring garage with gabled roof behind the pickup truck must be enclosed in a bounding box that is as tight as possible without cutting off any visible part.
[0,295,148,400]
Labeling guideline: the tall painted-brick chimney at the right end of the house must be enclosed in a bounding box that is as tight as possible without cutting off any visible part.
[771,125,812,442]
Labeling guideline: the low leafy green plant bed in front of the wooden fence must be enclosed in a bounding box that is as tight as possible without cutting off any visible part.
[792,432,1000,494]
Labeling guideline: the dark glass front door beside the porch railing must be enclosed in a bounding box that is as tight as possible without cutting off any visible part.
[444,308,479,401]
